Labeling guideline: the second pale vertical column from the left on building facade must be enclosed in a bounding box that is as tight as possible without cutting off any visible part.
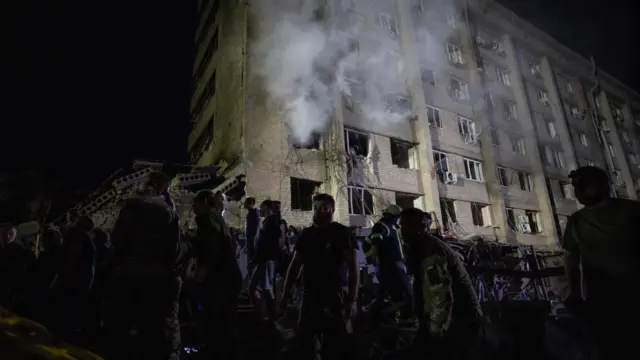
[459,7,509,241]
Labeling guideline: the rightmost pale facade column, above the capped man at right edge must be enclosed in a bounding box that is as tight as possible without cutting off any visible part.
[597,91,637,199]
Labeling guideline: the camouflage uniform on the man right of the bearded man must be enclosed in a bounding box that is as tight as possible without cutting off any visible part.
[411,235,482,359]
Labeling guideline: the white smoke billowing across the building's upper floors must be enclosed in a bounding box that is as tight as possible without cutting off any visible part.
[251,0,460,144]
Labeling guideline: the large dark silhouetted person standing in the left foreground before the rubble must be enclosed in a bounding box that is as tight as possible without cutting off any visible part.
[105,172,190,360]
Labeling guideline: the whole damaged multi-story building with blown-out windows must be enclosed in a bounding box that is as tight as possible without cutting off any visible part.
[189,0,640,248]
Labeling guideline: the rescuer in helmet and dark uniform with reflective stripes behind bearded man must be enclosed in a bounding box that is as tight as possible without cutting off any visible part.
[365,204,415,325]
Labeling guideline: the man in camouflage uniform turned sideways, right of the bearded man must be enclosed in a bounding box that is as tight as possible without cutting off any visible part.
[400,208,482,359]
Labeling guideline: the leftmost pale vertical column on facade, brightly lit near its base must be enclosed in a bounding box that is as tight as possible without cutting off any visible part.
[396,0,442,215]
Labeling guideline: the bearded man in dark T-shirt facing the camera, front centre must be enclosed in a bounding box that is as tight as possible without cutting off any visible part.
[280,194,359,360]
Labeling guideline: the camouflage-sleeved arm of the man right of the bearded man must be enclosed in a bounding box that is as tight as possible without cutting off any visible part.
[424,254,452,337]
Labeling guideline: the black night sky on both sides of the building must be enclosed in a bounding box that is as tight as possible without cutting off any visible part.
[0,0,640,188]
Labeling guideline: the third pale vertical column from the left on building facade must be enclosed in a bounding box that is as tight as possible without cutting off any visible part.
[503,35,559,247]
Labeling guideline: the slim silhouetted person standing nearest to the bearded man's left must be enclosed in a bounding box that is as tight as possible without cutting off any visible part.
[249,200,282,321]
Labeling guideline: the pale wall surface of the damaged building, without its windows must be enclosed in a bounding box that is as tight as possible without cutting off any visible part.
[189,0,640,247]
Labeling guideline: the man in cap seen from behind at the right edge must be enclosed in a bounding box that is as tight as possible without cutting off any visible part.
[562,166,640,359]
